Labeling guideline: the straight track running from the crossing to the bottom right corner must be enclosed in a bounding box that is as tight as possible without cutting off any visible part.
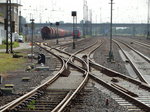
[51,38,150,112]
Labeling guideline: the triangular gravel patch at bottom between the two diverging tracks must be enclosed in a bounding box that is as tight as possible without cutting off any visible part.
[66,87,127,112]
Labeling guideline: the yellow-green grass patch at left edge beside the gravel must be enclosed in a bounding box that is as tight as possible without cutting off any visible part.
[0,53,26,73]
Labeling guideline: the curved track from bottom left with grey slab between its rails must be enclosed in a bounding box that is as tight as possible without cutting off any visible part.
[1,38,92,112]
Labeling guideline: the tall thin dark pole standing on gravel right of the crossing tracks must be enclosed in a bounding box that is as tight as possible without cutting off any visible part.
[109,0,114,62]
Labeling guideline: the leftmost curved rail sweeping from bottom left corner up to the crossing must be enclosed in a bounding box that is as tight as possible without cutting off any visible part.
[1,45,65,112]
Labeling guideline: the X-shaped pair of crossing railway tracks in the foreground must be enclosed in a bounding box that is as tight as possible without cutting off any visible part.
[3,37,150,112]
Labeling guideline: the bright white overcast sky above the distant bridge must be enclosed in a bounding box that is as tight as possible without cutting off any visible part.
[21,0,148,23]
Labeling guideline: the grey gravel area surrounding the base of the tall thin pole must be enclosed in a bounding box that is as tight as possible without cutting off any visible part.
[93,38,129,75]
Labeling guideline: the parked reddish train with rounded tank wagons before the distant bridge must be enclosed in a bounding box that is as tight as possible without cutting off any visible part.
[41,26,81,40]
